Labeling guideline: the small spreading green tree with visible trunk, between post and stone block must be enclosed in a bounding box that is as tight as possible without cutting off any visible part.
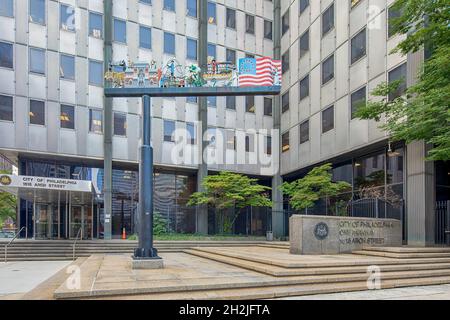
[187,171,272,233]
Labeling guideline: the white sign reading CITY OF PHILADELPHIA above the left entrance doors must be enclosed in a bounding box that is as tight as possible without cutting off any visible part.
[0,174,92,192]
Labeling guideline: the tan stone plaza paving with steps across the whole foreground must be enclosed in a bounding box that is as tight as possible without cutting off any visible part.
[0,245,450,300]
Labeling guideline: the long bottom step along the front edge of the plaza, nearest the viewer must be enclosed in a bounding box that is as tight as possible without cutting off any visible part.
[91,276,450,300]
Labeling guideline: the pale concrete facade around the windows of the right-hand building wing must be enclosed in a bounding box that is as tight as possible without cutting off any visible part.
[281,0,406,175]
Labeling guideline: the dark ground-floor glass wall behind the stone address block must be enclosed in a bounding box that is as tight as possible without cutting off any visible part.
[285,147,405,219]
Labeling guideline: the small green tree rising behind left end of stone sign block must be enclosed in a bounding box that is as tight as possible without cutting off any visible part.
[280,163,351,210]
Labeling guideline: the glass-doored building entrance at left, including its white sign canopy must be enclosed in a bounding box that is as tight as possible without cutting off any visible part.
[0,175,100,240]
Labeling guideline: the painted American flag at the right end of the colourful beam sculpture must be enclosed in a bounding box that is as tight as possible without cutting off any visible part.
[239,57,281,87]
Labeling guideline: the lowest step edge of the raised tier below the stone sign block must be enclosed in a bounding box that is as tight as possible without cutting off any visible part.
[183,249,450,277]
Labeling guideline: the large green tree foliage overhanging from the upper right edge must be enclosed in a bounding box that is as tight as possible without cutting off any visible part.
[356,0,450,161]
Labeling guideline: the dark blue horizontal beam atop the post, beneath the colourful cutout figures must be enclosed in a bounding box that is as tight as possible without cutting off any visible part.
[105,86,281,98]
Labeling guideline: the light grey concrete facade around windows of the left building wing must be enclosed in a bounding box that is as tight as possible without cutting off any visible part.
[0,0,273,174]
